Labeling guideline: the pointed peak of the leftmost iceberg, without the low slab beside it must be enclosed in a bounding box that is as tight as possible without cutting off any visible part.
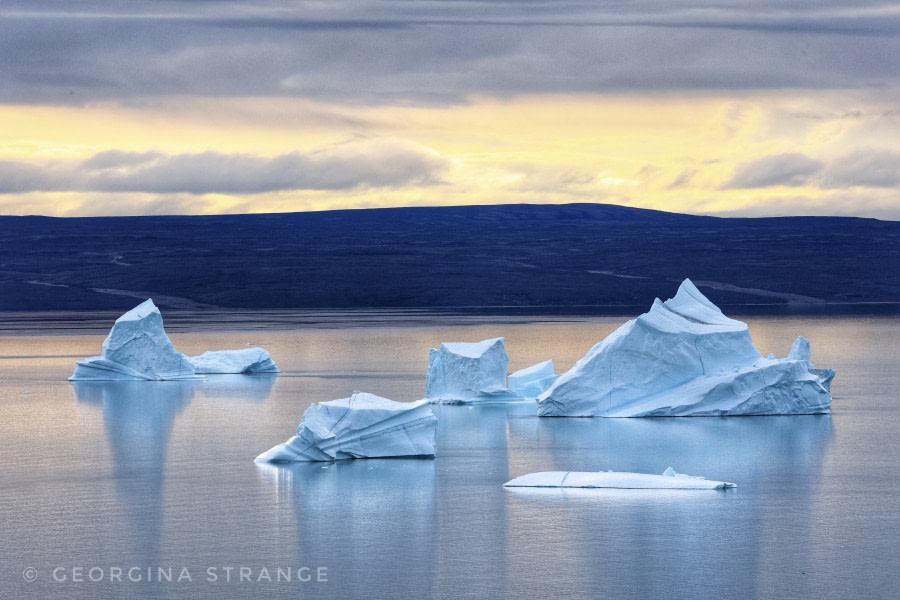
[69,300,198,381]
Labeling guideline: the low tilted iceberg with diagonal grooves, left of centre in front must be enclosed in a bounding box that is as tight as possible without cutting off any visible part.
[256,392,437,463]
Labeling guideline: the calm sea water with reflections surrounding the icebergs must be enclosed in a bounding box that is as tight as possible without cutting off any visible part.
[0,316,900,598]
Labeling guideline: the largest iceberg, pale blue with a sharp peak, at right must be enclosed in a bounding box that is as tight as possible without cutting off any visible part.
[537,279,834,417]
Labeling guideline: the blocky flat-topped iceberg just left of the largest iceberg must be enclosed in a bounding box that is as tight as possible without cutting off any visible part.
[425,338,521,404]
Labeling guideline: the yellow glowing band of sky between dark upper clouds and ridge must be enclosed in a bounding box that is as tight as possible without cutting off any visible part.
[0,92,900,218]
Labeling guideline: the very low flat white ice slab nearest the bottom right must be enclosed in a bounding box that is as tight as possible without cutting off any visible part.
[503,467,737,490]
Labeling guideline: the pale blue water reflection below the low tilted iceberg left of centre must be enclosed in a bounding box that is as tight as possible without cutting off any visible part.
[256,458,437,598]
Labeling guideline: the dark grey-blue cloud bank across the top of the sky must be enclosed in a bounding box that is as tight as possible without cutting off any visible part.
[0,0,900,105]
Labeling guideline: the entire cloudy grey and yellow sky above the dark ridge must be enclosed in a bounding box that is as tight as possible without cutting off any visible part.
[0,0,900,220]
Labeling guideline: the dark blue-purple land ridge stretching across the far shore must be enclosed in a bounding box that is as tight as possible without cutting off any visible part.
[0,204,900,310]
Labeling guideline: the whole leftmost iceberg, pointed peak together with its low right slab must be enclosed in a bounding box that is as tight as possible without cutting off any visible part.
[69,299,279,381]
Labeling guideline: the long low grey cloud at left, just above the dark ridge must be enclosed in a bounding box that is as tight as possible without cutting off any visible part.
[0,139,446,195]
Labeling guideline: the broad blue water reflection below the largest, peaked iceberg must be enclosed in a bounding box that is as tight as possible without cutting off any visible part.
[506,415,832,597]
